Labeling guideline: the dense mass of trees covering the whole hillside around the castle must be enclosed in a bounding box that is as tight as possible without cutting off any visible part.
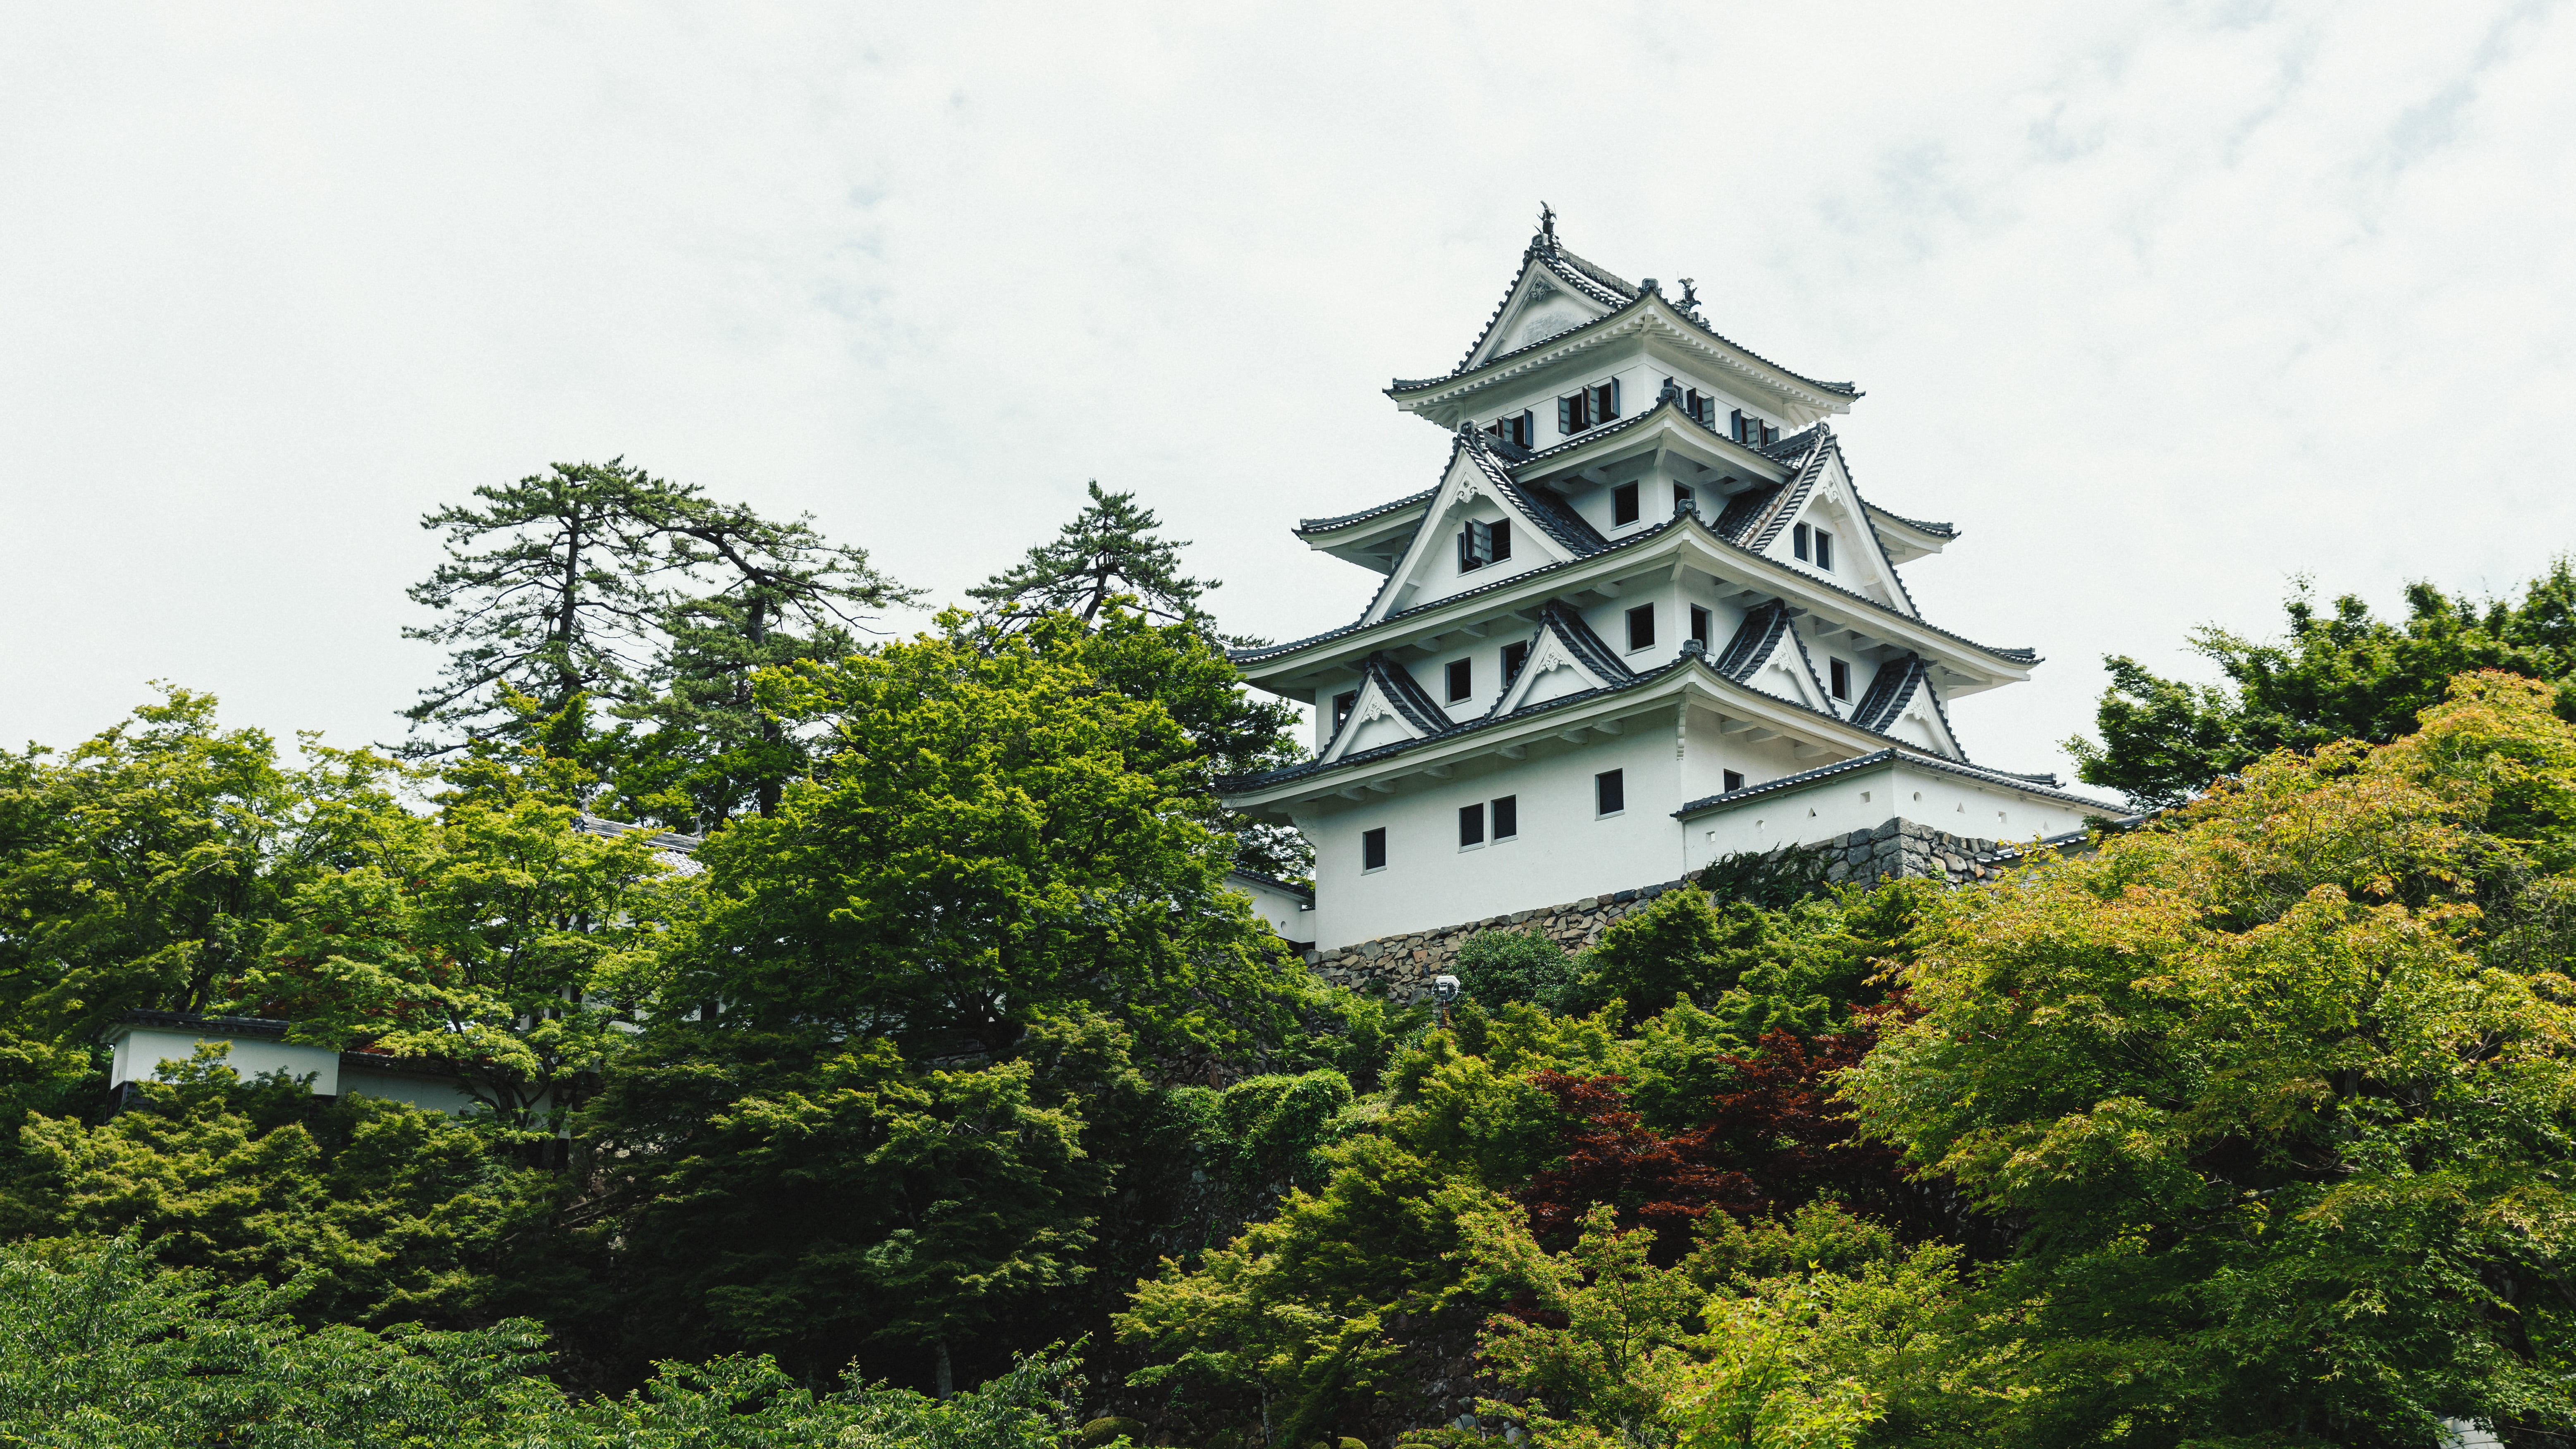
[25,464,2576,1449]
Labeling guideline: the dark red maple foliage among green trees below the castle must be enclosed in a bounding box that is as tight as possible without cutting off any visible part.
[1520,1021,1914,1261]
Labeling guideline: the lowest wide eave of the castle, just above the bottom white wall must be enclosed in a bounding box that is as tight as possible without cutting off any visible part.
[1216,655,1947,810]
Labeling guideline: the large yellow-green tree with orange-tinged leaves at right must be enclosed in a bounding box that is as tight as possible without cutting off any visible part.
[1850,673,2576,1447]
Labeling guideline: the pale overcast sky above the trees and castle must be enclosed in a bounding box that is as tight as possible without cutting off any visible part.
[0,0,2576,789]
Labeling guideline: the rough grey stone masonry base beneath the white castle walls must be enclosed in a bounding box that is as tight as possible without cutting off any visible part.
[1306,820,2084,1000]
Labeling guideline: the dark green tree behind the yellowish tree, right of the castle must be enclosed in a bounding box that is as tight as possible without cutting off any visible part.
[2066,560,2576,810]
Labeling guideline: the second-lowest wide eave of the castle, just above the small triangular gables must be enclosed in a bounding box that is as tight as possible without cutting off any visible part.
[1229,513,2043,691]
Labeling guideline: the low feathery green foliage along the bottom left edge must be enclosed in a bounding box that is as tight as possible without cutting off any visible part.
[0,1227,1082,1449]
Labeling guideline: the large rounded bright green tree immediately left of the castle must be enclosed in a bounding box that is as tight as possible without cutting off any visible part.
[667,616,1311,1052]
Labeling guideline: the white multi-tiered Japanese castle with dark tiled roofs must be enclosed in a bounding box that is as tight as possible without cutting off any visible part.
[1223,214,2105,949]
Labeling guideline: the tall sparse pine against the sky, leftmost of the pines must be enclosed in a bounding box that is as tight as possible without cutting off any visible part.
[402,459,688,756]
